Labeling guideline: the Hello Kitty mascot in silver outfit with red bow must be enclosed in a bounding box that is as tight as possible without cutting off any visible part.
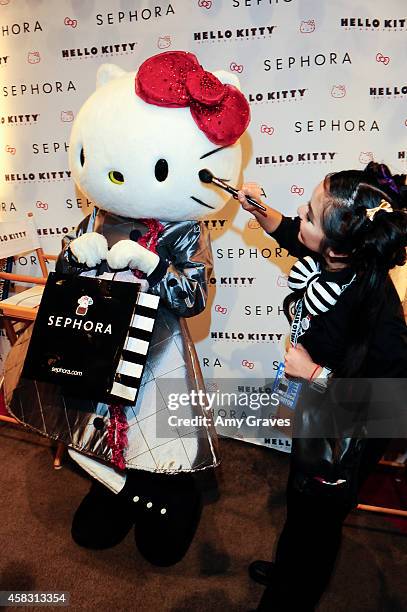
[6,51,250,566]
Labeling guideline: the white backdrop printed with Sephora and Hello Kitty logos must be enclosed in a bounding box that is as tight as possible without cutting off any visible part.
[0,0,407,451]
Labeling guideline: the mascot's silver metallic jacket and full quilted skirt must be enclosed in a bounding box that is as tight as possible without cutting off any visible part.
[5,209,219,473]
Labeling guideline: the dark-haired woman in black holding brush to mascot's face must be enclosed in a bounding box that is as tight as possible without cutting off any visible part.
[238,162,407,612]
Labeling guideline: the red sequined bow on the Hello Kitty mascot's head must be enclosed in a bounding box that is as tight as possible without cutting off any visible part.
[136,51,250,146]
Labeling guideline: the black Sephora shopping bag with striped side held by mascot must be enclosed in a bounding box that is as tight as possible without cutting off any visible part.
[23,272,159,404]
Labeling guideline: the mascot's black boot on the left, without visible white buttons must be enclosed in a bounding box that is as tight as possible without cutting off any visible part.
[71,481,134,550]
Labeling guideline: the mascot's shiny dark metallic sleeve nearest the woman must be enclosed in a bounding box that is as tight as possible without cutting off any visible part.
[147,222,213,317]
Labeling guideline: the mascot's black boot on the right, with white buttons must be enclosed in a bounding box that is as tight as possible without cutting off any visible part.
[129,471,202,567]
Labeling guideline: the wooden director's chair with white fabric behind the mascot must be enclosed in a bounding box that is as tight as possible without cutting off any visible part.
[0,213,65,469]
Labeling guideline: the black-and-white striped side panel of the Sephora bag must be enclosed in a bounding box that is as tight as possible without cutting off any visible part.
[111,293,160,402]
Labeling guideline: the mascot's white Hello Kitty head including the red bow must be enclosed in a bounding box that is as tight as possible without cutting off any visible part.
[69,51,250,221]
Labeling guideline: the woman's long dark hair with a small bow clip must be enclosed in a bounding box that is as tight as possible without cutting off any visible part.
[286,162,407,377]
